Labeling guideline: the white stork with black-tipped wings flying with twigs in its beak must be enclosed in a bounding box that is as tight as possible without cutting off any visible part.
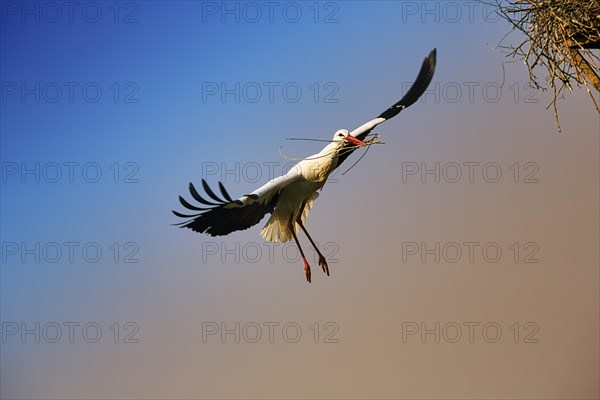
[173,49,436,282]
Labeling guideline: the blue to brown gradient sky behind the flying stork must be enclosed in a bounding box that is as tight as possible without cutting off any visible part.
[0,1,600,399]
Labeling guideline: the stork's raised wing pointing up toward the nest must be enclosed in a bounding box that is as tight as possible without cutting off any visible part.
[337,49,437,167]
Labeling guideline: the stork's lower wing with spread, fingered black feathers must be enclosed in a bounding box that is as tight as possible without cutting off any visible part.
[173,169,298,236]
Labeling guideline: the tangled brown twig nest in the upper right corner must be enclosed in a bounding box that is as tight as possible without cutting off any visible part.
[494,0,600,132]
